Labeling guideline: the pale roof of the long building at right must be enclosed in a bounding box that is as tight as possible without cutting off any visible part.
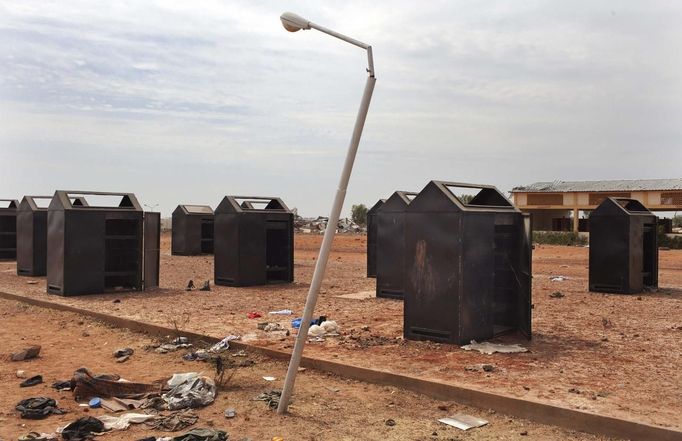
[512,179,682,193]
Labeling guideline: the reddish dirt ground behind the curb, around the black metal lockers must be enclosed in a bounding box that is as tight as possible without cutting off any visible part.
[0,235,682,438]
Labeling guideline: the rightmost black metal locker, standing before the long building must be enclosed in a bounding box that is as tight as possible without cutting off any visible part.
[589,198,658,294]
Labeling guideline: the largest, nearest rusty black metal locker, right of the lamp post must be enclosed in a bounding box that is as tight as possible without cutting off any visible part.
[404,181,532,344]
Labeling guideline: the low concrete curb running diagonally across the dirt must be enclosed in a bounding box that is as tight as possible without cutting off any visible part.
[0,291,682,441]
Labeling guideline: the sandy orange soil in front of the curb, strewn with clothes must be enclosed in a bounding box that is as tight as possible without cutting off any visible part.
[0,300,606,441]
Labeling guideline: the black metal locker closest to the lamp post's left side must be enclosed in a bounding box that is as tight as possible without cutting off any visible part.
[214,196,294,286]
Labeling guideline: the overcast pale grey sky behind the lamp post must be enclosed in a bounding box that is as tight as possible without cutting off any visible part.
[0,0,682,216]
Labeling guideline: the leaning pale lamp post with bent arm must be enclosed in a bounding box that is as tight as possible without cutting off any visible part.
[277,12,376,414]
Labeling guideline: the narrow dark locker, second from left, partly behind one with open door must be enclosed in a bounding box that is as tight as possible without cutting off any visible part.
[17,196,52,277]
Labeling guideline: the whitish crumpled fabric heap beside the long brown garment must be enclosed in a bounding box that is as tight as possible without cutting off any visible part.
[161,372,216,410]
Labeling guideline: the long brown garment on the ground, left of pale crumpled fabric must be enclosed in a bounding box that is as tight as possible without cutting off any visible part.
[71,368,162,401]
